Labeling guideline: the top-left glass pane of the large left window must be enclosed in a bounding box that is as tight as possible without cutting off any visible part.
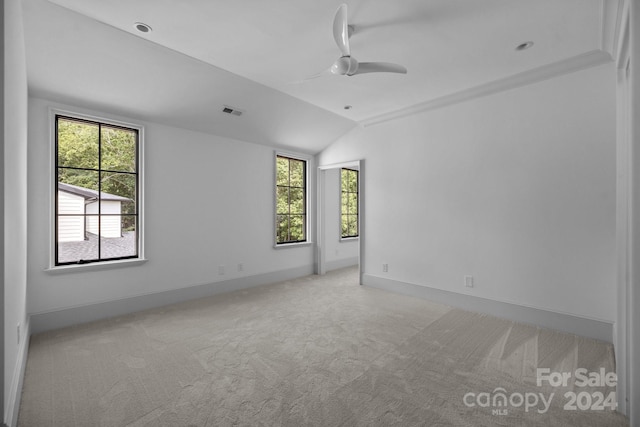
[57,118,98,169]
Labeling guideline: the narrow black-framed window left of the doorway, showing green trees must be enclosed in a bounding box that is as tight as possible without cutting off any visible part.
[276,155,307,245]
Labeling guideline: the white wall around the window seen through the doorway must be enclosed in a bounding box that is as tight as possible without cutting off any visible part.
[324,168,359,270]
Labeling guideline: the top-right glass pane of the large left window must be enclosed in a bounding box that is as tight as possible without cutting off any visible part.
[100,125,138,172]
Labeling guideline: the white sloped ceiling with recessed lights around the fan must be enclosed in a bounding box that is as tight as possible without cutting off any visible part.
[23,0,620,152]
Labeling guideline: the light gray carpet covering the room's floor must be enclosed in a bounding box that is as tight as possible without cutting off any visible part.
[19,269,628,427]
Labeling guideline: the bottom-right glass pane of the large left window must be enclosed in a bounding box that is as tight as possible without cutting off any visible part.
[100,219,138,259]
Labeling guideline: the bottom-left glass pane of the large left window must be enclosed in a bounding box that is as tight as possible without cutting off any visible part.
[57,215,98,263]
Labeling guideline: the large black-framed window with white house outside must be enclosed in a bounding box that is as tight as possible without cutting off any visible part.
[54,115,140,265]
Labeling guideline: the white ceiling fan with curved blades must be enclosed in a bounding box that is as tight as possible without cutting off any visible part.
[329,4,407,76]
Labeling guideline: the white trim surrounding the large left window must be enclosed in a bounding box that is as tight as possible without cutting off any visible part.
[46,108,147,273]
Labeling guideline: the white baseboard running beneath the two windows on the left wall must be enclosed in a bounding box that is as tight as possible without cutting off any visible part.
[31,265,314,334]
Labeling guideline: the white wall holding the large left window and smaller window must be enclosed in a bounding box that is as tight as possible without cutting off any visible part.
[28,98,315,313]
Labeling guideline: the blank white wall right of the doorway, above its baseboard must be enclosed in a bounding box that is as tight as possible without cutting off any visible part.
[318,64,616,322]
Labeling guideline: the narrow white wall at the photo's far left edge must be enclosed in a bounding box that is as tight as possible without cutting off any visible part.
[3,0,27,425]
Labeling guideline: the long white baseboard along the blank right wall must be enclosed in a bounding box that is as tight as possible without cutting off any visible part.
[362,274,614,343]
